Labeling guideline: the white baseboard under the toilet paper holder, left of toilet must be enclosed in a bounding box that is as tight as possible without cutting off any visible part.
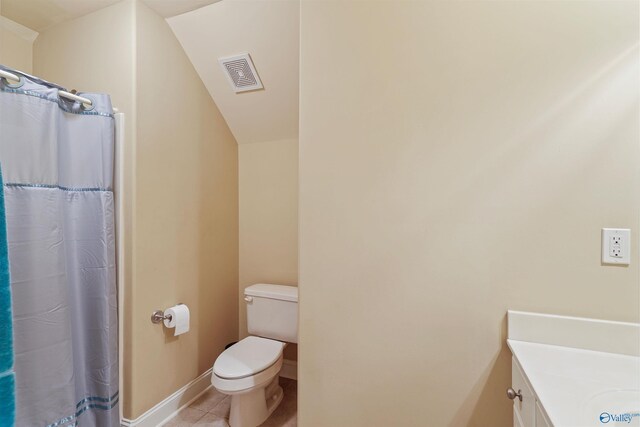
[120,368,211,427]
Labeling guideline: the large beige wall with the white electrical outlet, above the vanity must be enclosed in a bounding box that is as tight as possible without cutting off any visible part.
[298,1,640,427]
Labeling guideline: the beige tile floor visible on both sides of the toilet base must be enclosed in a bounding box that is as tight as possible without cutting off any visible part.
[163,378,298,427]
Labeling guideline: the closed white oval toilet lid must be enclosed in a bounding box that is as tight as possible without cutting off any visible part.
[213,337,284,379]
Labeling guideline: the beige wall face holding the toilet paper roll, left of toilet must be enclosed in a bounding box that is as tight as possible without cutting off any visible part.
[130,2,238,417]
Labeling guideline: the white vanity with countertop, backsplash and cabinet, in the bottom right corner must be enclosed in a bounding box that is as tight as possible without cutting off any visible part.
[505,310,640,427]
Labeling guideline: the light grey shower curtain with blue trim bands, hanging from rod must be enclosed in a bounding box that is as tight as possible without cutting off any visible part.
[0,67,119,427]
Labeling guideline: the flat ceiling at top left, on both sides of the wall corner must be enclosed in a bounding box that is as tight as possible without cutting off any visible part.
[0,0,220,32]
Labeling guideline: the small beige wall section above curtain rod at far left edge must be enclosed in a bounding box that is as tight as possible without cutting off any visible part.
[0,15,38,74]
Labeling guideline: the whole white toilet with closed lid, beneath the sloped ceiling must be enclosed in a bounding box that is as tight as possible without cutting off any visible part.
[211,284,298,427]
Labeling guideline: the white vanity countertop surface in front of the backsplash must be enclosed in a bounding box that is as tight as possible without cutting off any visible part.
[507,339,640,427]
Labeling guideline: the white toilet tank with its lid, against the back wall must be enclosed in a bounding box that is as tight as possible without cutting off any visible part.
[244,284,298,343]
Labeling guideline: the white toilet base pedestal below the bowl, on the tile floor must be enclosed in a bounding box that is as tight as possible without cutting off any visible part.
[229,375,284,427]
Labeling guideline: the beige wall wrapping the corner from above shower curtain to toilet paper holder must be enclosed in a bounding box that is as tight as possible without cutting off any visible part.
[34,0,238,419]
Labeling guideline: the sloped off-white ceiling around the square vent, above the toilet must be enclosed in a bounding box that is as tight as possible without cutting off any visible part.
[167,0,300,144]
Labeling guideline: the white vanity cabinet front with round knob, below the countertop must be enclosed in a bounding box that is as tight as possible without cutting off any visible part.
[507,357,553,427]
